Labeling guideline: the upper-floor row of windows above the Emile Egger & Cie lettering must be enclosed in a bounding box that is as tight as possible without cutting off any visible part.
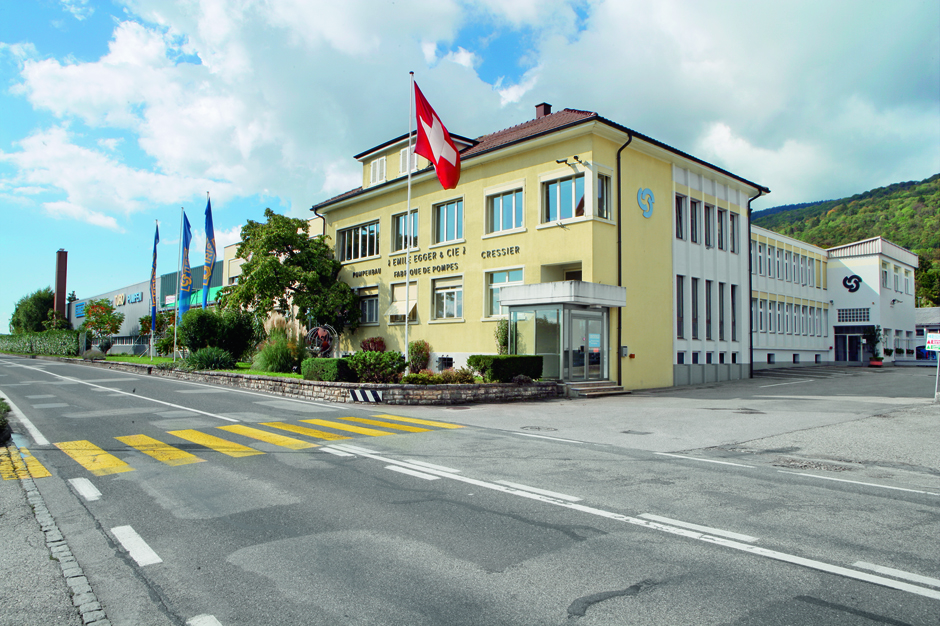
[336,171,611,262]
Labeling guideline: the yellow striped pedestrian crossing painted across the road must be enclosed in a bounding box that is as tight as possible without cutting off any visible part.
[43,415,463,480]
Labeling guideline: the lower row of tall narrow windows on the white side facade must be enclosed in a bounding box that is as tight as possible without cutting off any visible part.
[676,275,738,341]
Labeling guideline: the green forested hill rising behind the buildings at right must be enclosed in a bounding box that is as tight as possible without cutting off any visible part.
[752,174,940,263]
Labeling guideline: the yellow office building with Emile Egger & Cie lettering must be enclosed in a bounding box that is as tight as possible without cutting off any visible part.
[311,104,769,389]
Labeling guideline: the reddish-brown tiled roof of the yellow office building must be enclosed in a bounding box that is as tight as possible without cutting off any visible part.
[310,109,770,213]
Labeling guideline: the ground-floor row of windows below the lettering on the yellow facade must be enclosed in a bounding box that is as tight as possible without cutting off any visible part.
[358,268,523,324]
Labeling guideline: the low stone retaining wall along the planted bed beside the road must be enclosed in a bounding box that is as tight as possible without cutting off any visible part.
[25,357,564,405]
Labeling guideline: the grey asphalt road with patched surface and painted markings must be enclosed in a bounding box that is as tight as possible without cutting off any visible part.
[0,357,940,626]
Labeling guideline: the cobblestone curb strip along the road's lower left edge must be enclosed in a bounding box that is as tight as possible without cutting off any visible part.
[6,443,111,626]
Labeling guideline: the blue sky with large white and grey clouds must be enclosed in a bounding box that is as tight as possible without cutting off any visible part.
[0,0,940,332]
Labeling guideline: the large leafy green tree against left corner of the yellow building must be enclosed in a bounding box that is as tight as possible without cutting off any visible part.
[220,209,359,329]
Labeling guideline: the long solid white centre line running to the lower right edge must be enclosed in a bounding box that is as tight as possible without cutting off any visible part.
[338,444,940,600]
